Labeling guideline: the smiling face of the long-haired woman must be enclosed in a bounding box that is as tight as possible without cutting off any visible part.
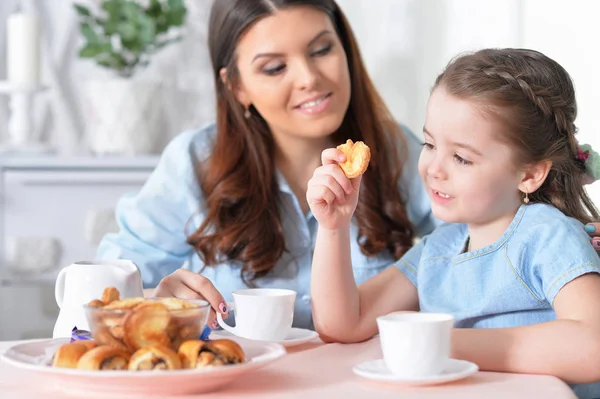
[230,6,350,138]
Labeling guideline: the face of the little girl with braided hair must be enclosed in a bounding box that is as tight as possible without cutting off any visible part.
[419,86,523,225]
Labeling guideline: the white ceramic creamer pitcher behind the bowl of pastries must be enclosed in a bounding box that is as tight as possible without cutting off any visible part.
[52,260,144,338]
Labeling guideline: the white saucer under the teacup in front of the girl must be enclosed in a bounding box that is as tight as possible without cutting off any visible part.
[352,359,479,385]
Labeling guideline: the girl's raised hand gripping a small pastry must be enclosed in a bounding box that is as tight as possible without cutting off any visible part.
[306,148,362,230]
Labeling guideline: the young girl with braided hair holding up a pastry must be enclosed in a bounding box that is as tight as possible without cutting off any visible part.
[307,49,600,397]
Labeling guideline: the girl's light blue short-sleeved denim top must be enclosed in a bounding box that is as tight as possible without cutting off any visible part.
[396,204,600,398]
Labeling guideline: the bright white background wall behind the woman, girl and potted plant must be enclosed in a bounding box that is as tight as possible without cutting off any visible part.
[0,0,600,201]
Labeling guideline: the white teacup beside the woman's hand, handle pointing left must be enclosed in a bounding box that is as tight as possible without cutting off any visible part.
[217,288,296,341]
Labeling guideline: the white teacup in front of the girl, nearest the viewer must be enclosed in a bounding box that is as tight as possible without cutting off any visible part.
[377,312,454,378]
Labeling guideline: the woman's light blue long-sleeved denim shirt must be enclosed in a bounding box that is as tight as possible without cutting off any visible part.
[97,125,437,328]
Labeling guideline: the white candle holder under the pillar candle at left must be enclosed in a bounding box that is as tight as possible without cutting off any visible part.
[0,81,53,154]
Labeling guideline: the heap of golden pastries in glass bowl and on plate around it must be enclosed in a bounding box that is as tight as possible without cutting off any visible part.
[52,287,245,370]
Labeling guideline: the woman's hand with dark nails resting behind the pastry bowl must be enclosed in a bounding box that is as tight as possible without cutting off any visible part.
[153,269,229,329]
